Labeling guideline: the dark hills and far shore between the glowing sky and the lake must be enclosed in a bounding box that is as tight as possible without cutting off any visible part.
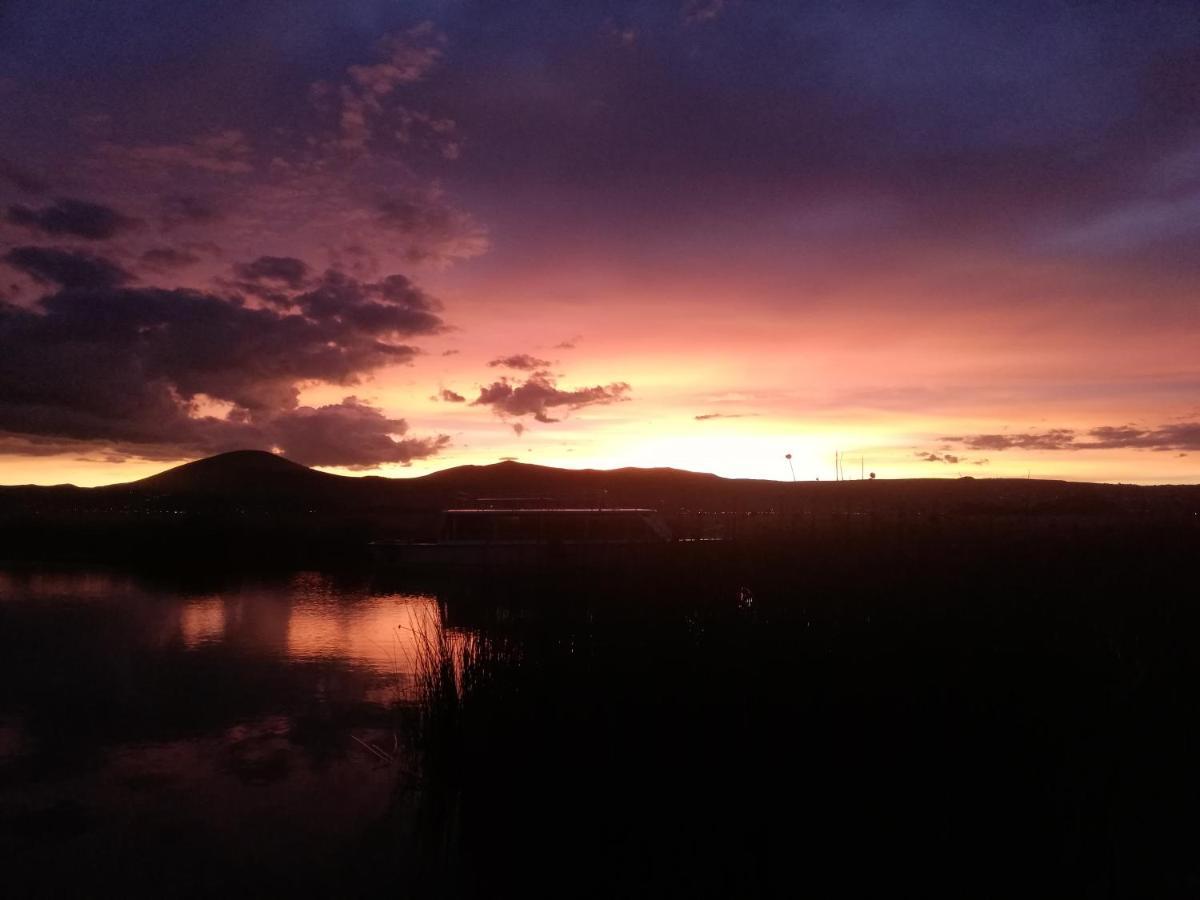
[0,450,1200,562]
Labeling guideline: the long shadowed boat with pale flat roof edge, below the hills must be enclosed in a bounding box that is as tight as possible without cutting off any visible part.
[371,509,673,569]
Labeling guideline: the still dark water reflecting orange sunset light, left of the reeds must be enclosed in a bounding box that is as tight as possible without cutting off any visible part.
[0,570,438,895]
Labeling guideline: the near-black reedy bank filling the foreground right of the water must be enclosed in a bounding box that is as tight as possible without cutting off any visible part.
[380,518,1200,898]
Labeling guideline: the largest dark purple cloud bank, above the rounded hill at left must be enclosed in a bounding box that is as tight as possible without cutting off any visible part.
[0,254,445,466]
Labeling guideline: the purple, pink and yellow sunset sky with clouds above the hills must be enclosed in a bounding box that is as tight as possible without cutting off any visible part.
[0,0,1200,485]
